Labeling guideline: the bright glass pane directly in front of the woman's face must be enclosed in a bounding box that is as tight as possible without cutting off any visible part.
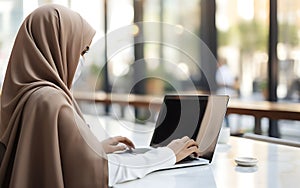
[69,0,105,92]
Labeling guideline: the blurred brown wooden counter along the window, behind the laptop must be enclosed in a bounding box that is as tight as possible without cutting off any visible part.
[74,92,300,136]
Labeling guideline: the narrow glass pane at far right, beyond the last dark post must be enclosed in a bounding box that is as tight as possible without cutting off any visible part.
[277,0,300,102]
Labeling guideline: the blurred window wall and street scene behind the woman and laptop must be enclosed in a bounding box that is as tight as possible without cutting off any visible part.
[0,0,300,140]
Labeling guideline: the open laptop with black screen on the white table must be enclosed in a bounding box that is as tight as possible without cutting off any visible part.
[130,95,229,169]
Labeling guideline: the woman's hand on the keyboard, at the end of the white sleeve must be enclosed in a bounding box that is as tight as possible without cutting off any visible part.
[167,136,199,162]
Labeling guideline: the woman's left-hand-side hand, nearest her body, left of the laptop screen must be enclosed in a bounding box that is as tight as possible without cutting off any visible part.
[101,136,135,154]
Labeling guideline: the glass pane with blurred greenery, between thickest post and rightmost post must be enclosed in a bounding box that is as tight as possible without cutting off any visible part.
[216,0,269,100]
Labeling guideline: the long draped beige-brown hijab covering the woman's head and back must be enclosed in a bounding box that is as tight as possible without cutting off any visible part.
[0,5,108,188]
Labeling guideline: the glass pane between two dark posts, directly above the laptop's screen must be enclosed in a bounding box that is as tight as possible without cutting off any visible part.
[144,0,200,95]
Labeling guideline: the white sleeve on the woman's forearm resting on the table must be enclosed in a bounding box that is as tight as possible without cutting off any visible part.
[107,147,176,186]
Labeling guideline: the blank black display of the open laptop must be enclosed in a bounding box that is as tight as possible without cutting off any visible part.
[151,95,208,147]
